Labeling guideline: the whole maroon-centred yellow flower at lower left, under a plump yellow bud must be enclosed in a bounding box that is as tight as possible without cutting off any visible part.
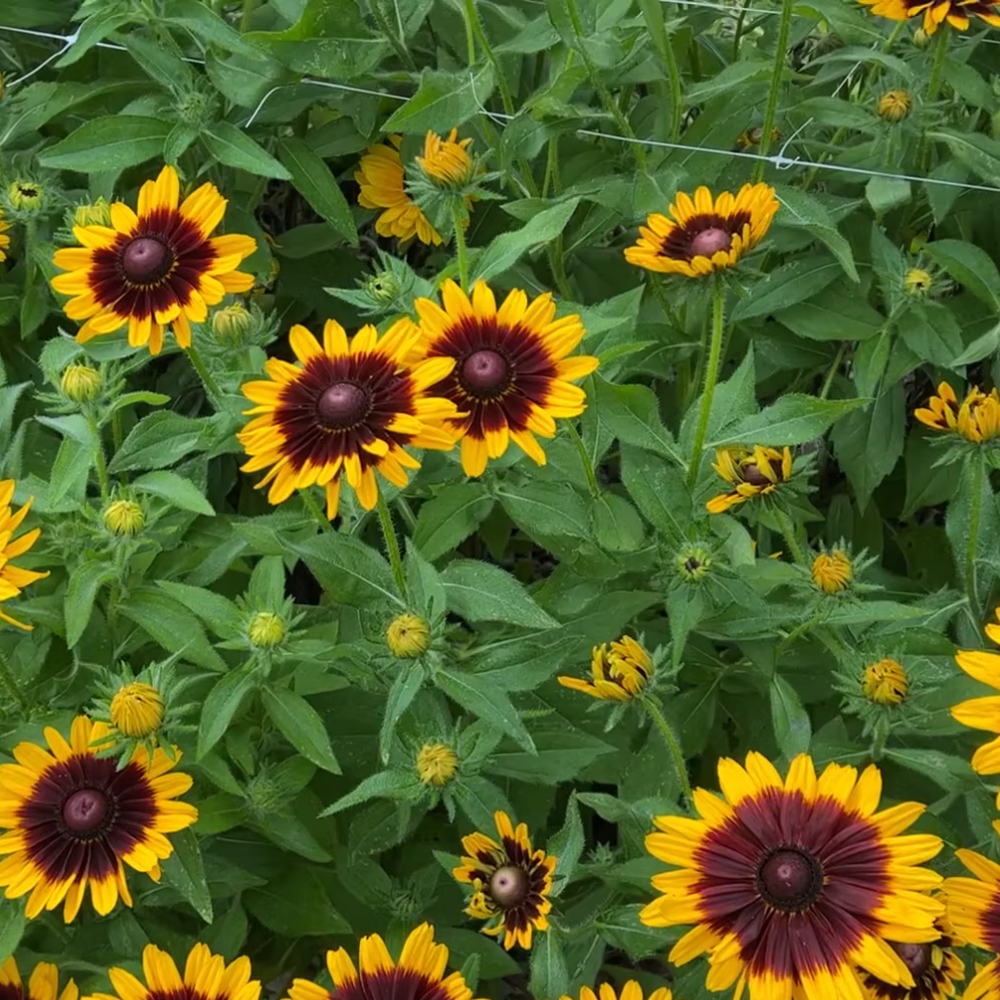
[0,715,198,920]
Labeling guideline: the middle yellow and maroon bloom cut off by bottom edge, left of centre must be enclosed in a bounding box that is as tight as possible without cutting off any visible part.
[288,924,482,1000]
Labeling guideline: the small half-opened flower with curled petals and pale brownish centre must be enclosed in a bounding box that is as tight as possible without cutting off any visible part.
[456,811,556,948]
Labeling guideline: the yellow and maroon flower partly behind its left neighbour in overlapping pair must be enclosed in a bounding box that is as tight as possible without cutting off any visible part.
[413,280,598,476]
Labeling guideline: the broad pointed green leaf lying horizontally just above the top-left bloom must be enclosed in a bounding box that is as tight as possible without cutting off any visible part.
[37,115,173,174]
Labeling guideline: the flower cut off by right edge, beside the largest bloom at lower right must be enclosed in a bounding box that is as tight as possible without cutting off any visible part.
[943,852,1000,1000]
